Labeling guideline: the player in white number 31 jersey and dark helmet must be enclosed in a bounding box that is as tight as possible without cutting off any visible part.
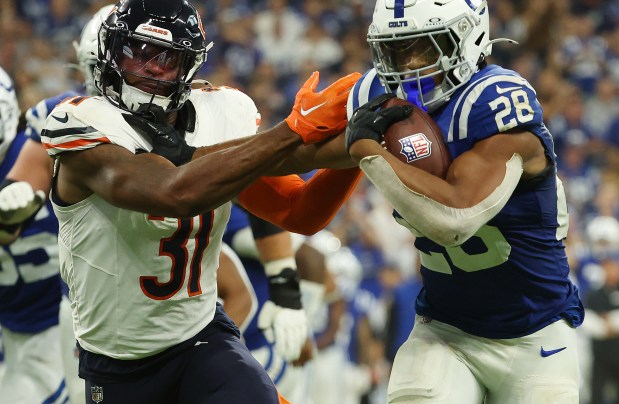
[41,0,359,403]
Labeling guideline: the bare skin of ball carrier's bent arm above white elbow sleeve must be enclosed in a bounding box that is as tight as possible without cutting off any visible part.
[350,131,549,208]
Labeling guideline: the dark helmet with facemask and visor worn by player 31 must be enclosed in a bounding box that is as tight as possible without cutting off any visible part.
[94,0,212,117]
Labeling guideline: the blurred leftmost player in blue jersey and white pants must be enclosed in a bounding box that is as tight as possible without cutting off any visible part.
[0,69,67,404]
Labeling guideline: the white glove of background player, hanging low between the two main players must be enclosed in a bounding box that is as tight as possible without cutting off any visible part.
[258,300,307,361]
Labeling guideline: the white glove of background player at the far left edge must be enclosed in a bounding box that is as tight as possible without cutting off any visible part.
[0,181,45,225]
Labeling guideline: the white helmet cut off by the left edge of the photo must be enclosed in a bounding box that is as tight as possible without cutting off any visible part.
[0,68,20,162]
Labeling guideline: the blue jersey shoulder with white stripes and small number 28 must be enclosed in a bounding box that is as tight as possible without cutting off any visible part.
[447,66,542,145]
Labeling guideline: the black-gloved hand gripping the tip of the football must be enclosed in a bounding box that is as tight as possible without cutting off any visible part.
[346,93,413,152]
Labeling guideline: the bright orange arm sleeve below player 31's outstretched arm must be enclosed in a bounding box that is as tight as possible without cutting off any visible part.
[239,168,361,235]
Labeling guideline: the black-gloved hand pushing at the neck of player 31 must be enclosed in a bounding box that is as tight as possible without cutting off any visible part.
[123,105,196,166]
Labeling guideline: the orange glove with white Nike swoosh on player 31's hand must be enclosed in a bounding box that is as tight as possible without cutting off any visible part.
[286,72,361,143]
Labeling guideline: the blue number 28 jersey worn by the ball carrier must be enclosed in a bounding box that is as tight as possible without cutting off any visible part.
[348,65,584,338]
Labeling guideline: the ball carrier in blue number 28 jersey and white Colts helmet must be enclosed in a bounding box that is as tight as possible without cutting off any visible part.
[346,0,584,404]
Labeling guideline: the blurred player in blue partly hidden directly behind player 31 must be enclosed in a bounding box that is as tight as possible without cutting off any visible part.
[0,5,113,404]
